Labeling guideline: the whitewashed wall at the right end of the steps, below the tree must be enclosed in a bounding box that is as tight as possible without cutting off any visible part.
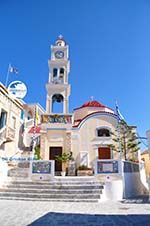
[96,161,148,201]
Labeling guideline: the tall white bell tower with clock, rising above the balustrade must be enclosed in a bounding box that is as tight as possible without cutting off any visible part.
[46,35,70,114]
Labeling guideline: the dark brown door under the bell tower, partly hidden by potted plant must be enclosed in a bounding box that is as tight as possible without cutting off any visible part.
[49,147,62,176]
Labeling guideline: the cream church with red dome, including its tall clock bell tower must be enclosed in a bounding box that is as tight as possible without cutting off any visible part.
[40,37,122,175]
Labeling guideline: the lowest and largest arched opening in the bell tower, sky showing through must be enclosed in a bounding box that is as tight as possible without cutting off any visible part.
[52,94,64,113]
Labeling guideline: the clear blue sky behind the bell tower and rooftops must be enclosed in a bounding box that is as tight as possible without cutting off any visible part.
[0,0,150,147]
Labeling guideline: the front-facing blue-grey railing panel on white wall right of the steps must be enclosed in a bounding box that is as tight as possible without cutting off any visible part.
[95,159,119,174]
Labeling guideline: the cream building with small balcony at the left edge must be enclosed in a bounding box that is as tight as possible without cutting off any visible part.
[0,83,23,157]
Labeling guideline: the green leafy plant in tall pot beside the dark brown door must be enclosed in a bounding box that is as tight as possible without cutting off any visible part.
[55,152,70,176]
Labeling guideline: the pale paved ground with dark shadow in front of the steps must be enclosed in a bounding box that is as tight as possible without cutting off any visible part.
[0,199,150,226]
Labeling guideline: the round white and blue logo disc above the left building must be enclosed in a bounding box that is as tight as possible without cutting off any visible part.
[8,81,27,99]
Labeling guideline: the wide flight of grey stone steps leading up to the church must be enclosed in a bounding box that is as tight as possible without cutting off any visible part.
[0,177,103,202]
